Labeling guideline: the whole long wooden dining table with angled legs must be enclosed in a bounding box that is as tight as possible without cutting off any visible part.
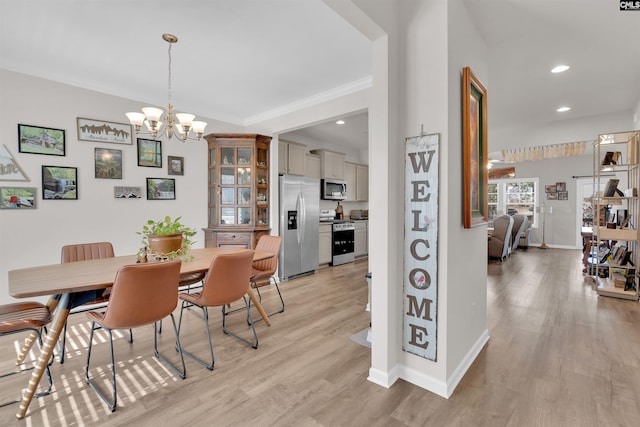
[9,247,274,419]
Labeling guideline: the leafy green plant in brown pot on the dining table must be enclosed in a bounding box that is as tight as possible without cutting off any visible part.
[137,216,197,259]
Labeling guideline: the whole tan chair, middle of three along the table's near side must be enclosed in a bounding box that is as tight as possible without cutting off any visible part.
[178,251,258,371]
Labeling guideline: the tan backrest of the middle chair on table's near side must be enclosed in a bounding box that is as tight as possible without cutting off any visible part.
[197,251,254,307]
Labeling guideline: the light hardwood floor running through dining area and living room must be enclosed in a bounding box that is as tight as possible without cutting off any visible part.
[0,248,640,427]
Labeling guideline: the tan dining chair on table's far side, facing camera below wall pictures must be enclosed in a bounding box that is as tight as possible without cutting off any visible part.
[56,242,133,364]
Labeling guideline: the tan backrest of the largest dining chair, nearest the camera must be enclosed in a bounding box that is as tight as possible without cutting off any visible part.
[101,259,182,329]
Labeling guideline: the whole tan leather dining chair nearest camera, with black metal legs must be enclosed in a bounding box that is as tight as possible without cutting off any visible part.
[85,260,186,412]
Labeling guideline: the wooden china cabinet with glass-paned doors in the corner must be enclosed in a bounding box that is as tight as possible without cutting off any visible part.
[204,133,271,249]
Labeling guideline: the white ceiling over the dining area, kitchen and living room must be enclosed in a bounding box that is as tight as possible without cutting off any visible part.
[0,0,640,155]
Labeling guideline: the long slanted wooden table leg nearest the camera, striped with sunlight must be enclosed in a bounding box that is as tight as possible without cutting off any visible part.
[16,294,71,419]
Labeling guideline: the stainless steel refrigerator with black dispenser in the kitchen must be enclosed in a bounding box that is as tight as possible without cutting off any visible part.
[278,175,320,280]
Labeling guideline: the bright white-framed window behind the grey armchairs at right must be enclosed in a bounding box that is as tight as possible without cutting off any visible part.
[487,178,538,227]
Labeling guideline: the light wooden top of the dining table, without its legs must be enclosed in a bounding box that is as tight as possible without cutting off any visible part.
[9,247,273,298]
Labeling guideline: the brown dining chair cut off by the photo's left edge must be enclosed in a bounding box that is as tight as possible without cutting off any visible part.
[0,301,53,407]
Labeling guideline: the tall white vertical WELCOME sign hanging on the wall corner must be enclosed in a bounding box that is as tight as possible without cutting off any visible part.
[402,134,440,362]
